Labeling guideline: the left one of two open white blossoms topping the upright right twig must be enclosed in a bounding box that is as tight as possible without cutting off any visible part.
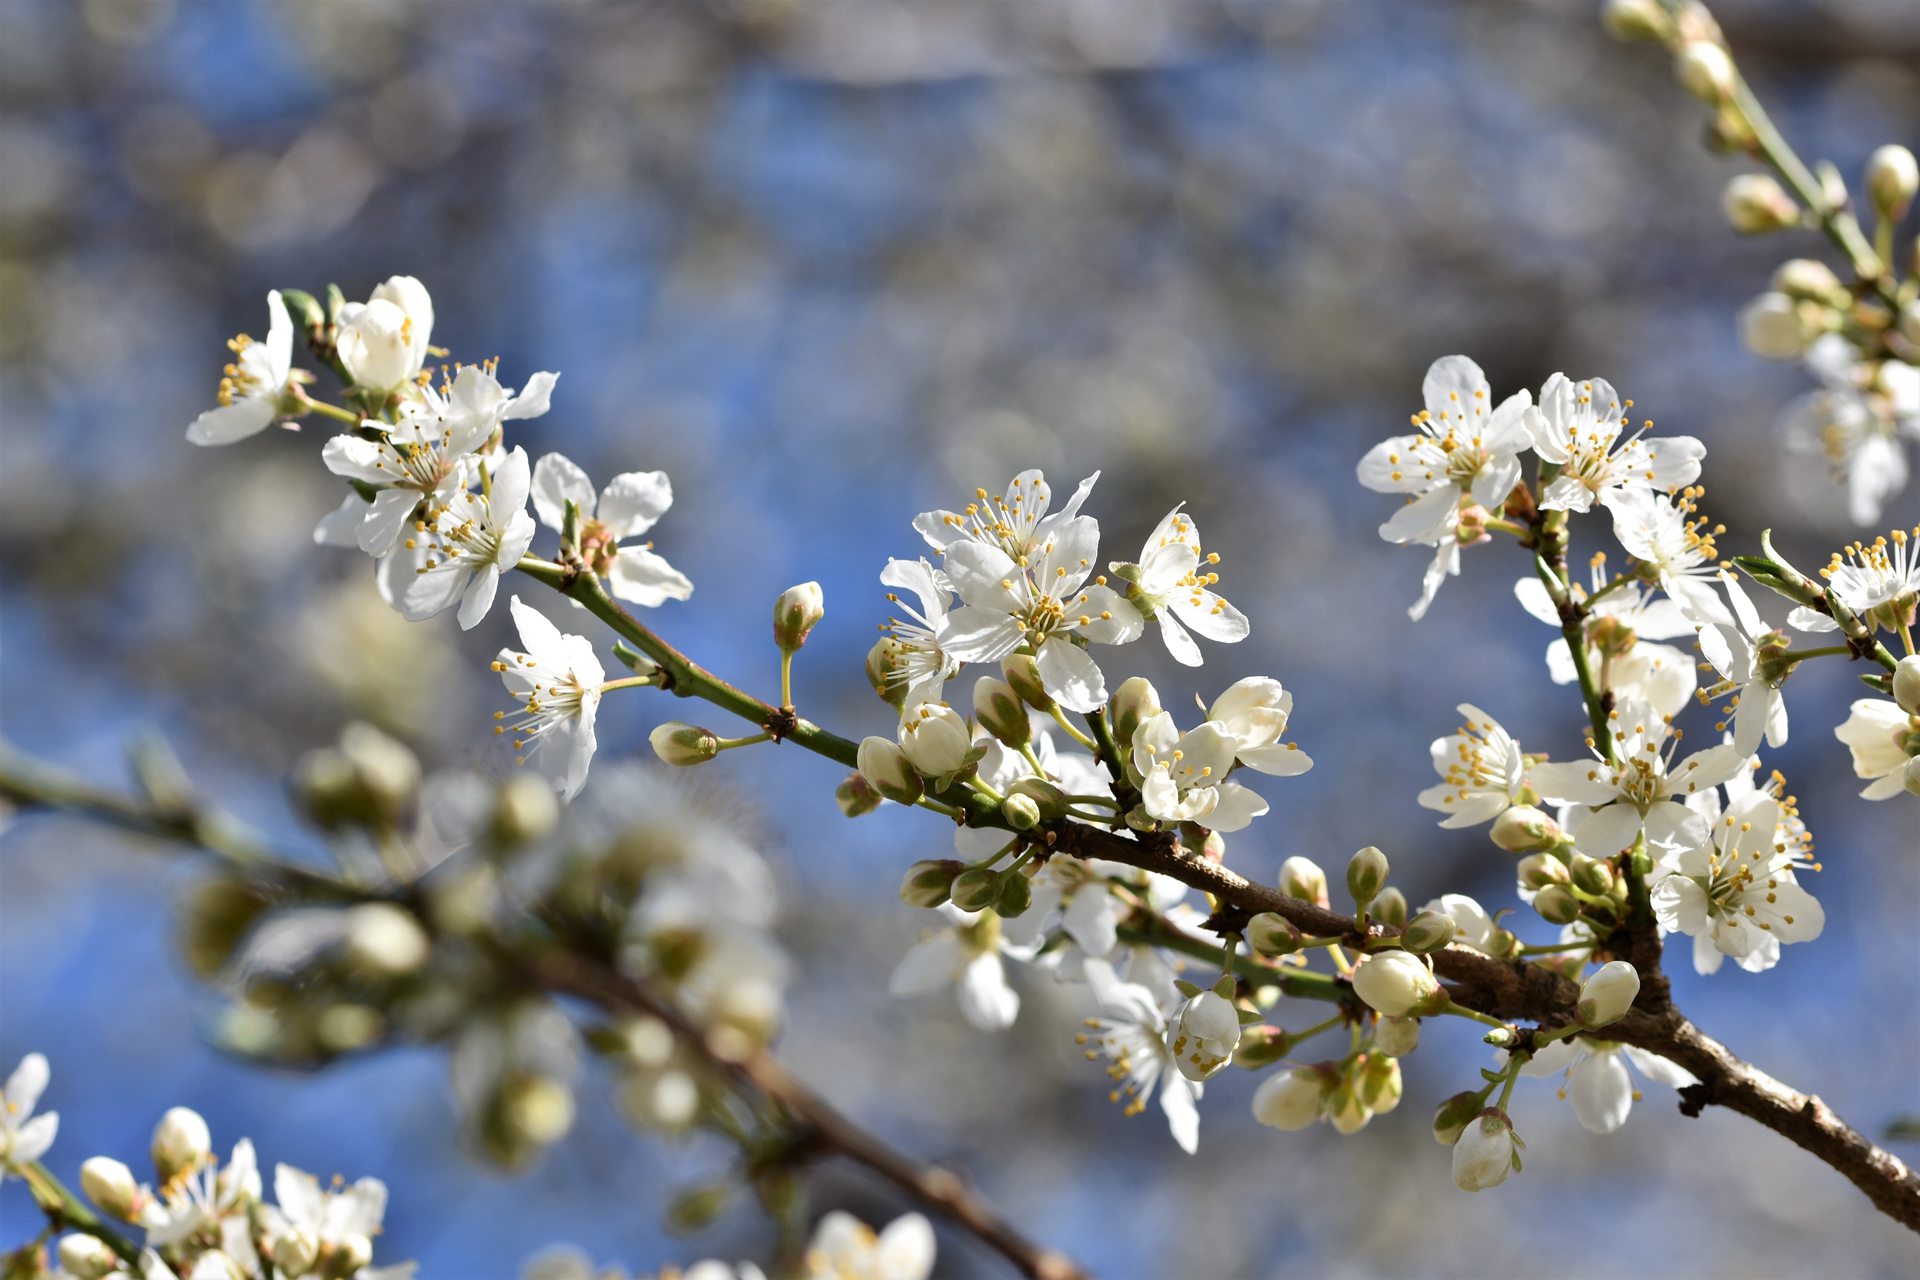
[1359,355,1532,543]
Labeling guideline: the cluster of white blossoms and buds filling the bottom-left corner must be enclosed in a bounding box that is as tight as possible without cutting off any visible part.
[0,1054,415,1280]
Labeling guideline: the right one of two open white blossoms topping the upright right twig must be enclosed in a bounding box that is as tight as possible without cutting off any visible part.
[1526,374,1707,510]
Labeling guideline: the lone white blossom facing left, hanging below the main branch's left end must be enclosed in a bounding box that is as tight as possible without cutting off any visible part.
[493,597,607,800]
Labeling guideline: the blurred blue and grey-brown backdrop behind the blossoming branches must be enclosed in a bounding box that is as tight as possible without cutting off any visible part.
[0,0,1920,1276]
